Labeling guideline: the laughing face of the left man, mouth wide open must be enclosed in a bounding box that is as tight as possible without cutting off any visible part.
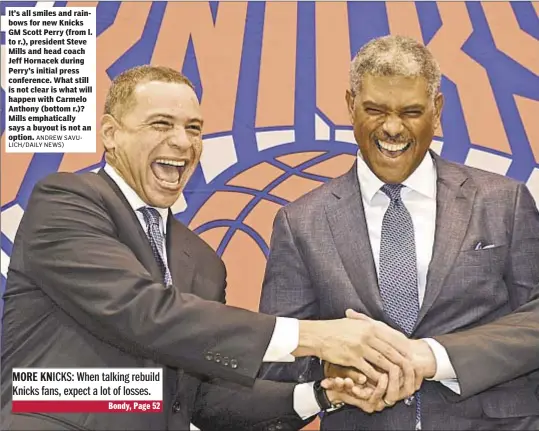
[102,81,202,208]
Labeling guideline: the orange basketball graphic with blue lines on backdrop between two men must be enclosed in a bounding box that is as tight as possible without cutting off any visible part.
[189,150,354,310]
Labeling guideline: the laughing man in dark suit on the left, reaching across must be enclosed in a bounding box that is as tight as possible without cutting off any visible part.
[1,66,411,430]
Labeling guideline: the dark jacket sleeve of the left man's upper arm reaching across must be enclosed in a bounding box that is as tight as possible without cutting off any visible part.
[18,173,275,385]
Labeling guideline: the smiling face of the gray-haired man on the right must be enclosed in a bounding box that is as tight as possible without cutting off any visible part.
[346,75,443,184]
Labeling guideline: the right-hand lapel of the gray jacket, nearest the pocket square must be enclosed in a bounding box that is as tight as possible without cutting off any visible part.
[416,154,476,327]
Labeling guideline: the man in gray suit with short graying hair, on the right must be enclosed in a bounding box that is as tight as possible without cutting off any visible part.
[260,36,539,430]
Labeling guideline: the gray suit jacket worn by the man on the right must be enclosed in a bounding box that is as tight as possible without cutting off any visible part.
[260,153,539,430]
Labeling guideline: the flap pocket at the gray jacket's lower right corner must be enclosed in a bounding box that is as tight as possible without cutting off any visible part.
[480,386,539,419]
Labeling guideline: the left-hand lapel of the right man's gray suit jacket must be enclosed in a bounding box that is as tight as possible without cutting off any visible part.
[326,162,385,320]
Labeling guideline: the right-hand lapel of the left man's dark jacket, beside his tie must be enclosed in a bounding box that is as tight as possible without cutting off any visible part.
[166,210,195,293]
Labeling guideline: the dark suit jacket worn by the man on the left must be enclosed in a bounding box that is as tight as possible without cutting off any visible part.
[0,171,308,431]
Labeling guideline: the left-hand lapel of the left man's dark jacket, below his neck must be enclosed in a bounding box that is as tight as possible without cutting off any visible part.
[98,169,163,280]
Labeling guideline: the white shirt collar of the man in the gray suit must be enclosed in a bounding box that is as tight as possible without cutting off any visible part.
[357,150,436,203]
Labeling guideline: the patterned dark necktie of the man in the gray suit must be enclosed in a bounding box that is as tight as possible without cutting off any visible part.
[379,184,421,429]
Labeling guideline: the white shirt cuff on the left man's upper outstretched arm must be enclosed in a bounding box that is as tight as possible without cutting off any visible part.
[262,317,299,362]
